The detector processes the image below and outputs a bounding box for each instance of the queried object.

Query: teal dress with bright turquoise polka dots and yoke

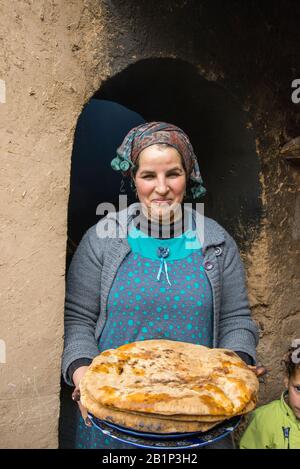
[77,222,213,449]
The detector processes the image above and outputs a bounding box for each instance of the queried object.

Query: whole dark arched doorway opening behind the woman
[60,59,261,448]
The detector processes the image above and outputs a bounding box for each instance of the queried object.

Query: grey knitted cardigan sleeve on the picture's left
[62,226,102,386]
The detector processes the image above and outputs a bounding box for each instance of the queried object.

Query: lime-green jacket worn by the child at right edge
[240,393,300,449]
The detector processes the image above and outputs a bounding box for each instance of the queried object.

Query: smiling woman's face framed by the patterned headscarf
[134,145,186,222]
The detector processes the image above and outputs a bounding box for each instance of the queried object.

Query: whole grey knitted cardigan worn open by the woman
[62,204,258,386]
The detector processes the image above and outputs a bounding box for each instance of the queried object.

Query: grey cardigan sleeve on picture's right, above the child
[218,232,258,363]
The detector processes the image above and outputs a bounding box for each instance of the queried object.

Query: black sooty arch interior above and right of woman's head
[94,58,262,244]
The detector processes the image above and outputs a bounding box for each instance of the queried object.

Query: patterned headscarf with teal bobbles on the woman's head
[111,122,206,199]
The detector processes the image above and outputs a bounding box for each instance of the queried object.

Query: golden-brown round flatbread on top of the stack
[80,339,258,421]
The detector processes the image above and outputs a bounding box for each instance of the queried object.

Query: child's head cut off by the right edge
[284,341,300,420]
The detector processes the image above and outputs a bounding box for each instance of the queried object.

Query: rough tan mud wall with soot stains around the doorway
[0,0,300,448]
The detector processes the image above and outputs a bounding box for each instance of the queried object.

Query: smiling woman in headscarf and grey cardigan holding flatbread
[62,122,258,448]
